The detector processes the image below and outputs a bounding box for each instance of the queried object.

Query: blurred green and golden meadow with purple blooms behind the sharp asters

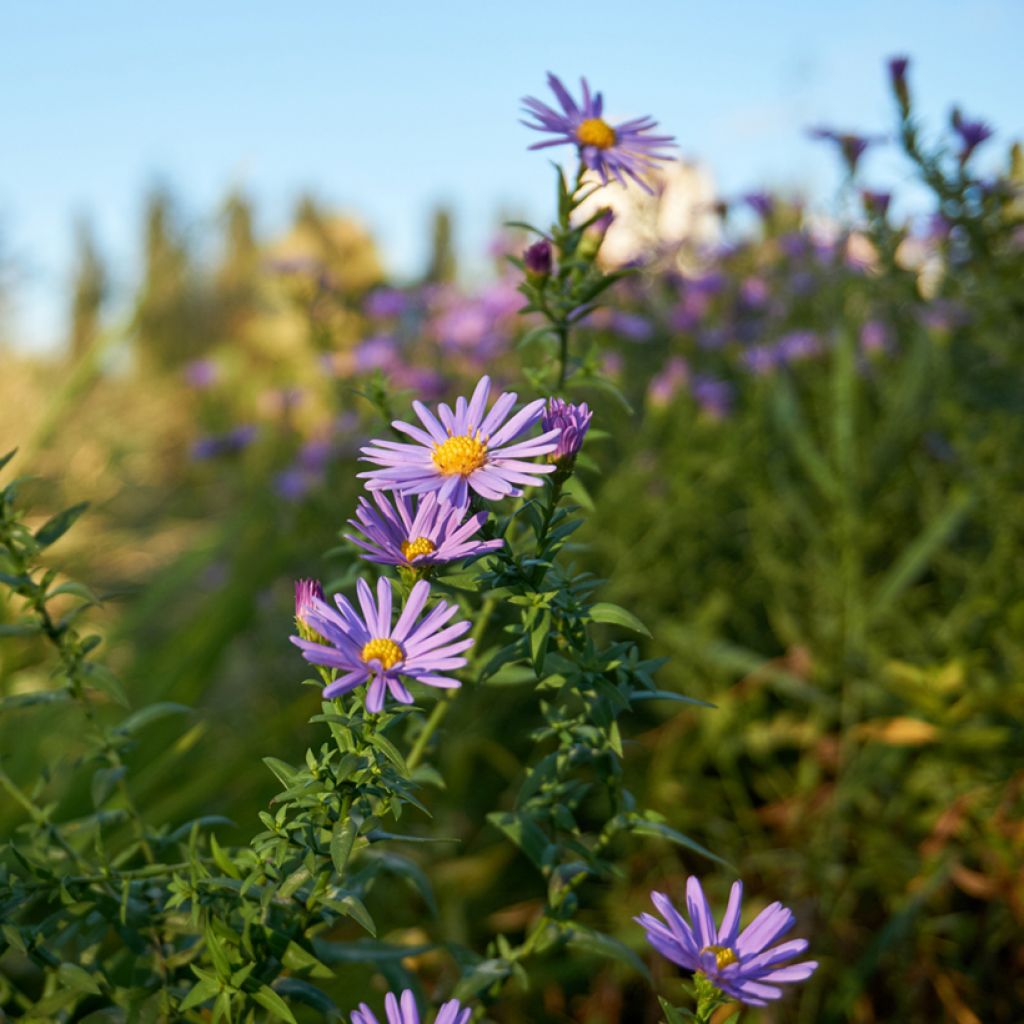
[0,59,1024,1024]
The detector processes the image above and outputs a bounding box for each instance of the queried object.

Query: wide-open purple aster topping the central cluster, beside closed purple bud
[359,377,560,508]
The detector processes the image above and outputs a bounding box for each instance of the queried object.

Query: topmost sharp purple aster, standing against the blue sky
[522,72,675,194]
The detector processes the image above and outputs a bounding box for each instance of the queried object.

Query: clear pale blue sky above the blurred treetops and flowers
[0,0,1024,345]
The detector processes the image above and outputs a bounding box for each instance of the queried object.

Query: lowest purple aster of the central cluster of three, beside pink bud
[291,577,473,712]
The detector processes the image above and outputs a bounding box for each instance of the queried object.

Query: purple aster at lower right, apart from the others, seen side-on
[635,876,818,1007]
